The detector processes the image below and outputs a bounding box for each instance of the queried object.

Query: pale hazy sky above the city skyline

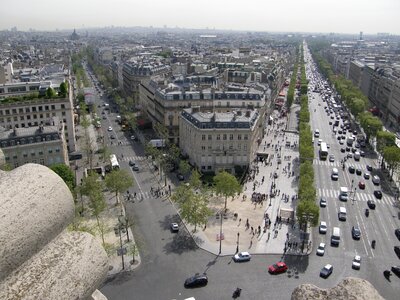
[0,0,400,34]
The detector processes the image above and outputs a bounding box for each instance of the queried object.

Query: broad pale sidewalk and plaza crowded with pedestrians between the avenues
[180,104,312,255]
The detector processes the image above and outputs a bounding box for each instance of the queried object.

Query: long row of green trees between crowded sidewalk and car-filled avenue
[296,48,319,226]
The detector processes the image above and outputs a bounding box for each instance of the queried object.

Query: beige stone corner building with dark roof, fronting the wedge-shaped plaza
[179,106,263,173]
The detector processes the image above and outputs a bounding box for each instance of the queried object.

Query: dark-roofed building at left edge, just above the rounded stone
[0,126,69,168]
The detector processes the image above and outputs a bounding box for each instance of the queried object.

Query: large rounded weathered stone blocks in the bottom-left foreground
[0,164,108,299]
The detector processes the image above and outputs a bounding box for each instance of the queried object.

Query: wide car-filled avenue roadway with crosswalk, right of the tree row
[304,47,400,299]
